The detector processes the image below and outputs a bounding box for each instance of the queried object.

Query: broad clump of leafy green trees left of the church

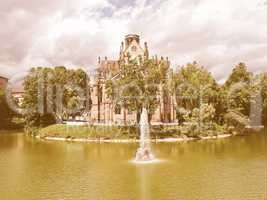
[23,66,90,132]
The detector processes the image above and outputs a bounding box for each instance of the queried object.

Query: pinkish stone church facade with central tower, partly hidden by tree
[90,34,176,124]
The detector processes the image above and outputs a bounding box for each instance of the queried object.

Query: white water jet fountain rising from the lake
[135,108,155,162]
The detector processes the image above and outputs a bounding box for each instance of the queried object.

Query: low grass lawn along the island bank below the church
[37,124,230,139]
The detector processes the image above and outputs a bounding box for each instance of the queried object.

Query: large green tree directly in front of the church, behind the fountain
[106,59,168,122]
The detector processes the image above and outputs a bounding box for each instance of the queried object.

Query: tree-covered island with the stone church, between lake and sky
[1,34,267,142]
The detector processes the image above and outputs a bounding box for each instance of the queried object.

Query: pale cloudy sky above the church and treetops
[0,0,267,82]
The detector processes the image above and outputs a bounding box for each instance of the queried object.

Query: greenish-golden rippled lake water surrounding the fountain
[0,133,267,200]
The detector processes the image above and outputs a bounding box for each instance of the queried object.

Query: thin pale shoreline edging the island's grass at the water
[35,134,235,143]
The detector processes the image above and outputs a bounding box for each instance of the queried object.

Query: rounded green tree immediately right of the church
[171,62,219,122]
